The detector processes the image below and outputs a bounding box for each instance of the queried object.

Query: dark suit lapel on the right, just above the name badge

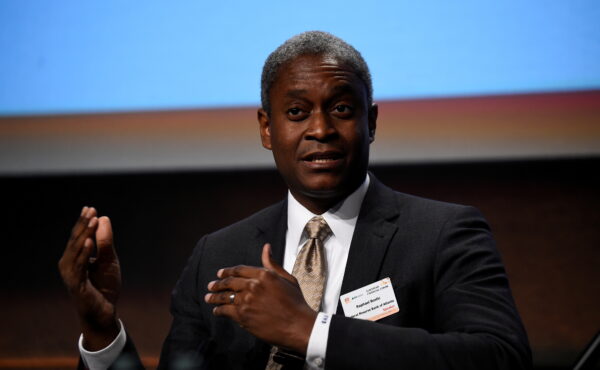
[337,174,398,314]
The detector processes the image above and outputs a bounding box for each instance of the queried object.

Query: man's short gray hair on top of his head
[260,31,373,113]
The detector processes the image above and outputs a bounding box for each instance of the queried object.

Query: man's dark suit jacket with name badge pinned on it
[108,175,531,370]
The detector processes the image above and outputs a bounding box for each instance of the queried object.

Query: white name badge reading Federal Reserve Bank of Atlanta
[340,278,400,321]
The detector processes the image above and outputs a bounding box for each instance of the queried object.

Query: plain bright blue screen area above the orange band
[0,0,600,116]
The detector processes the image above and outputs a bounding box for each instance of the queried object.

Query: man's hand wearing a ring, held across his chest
[205,244,317,354]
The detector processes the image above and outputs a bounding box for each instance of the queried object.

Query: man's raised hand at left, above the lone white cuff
[58,207,121,351]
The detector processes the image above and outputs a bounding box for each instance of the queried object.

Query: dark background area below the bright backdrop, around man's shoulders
[0,158,600,369]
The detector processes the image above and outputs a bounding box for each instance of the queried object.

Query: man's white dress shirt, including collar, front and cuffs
[79,175,370,370]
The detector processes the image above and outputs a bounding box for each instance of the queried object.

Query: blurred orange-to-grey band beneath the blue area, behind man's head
[0,90,600,175]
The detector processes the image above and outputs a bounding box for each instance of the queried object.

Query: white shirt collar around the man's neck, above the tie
[287,174,370,247]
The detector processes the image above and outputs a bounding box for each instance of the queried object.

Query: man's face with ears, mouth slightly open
[258,55,377,212]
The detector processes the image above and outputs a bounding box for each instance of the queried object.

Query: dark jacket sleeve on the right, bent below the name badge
[325,207,531,370]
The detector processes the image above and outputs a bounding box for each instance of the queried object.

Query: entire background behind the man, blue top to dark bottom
[0,0,600,369]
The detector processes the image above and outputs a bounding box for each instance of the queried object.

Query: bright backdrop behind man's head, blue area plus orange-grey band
[0,0,600,175]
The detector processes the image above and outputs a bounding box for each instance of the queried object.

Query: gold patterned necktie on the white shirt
[266,216,331,370]
